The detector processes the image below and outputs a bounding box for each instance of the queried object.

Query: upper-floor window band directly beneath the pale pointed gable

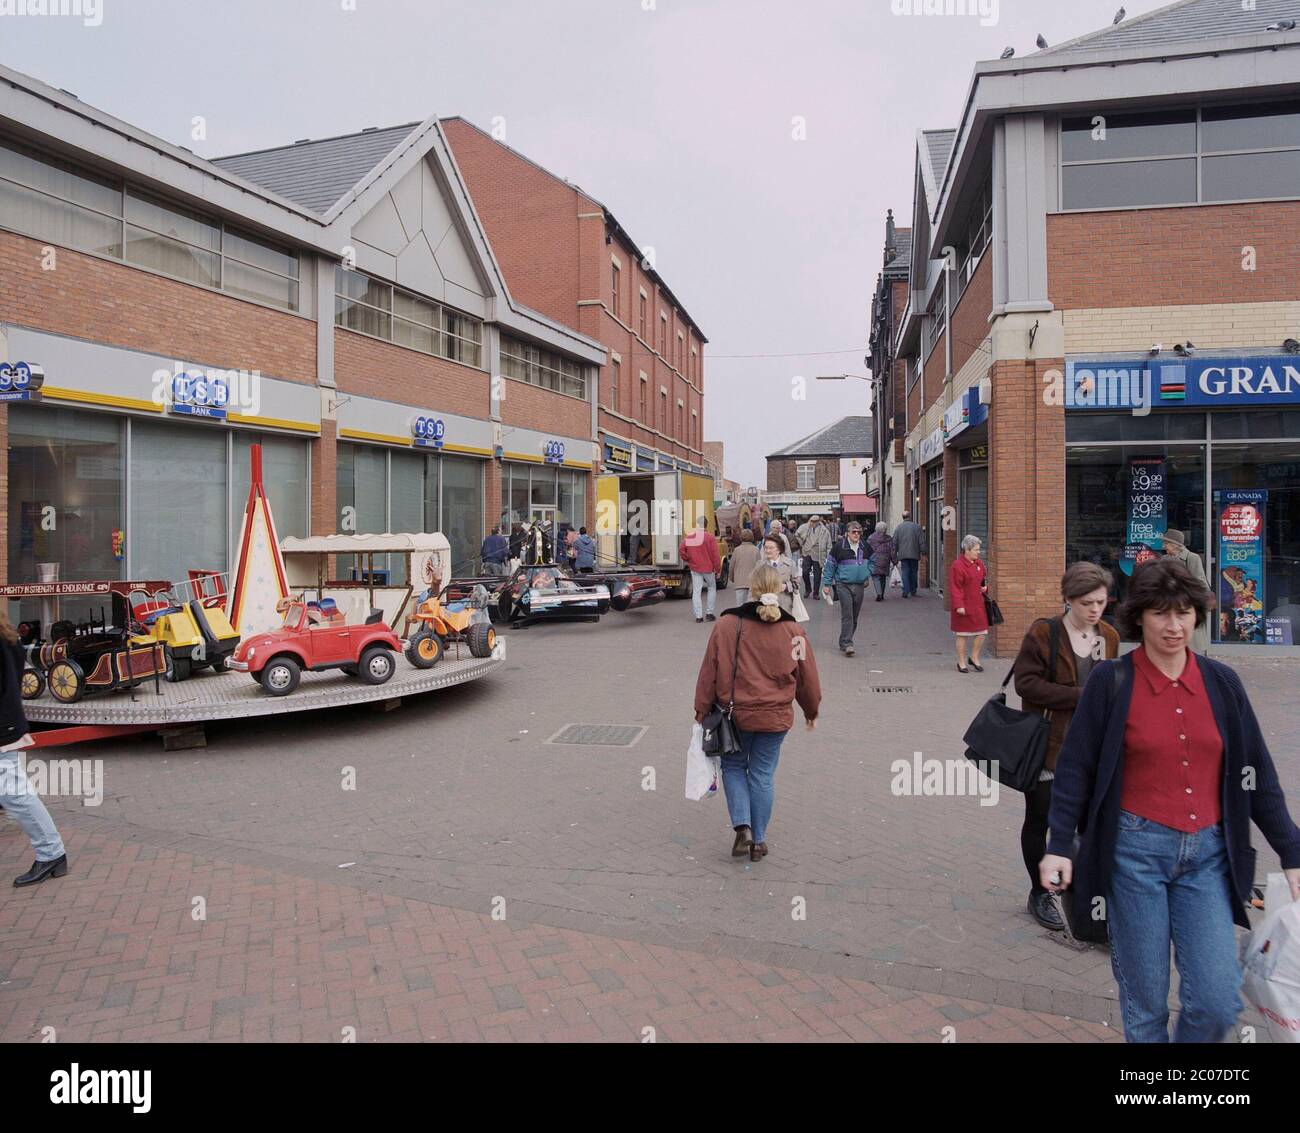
[334,268,484,366]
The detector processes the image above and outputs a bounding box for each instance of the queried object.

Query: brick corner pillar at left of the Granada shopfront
[988,359,1065,656]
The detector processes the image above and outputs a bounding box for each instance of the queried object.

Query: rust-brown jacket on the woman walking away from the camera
[696,602,822,732]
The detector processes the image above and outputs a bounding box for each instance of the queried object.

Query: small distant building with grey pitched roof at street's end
[763,417,876,522]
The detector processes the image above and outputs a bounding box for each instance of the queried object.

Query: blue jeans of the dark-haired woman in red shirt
[1106,811,1242,1042]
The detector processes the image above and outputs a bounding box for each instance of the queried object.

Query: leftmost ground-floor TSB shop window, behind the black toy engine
[8,404,126,621]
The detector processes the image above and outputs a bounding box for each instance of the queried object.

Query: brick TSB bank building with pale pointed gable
[0,69,606,616]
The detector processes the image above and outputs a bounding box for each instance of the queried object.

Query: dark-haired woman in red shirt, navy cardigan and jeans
[1039,559,1300,1042]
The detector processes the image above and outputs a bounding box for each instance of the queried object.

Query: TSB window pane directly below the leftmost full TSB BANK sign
[127,421,230,582]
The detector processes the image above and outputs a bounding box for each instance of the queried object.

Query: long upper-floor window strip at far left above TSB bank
[0,139,298,311]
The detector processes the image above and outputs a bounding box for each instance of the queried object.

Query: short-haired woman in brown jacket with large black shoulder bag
[1011,563,1119,932]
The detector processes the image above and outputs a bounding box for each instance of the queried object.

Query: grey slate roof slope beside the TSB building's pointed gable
[212,122,420,216]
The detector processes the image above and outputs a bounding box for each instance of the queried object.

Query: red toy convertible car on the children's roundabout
[230,596,402,696]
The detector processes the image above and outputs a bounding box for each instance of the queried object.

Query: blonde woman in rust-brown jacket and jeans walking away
[696,565,816,861]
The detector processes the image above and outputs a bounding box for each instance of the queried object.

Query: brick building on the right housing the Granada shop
[881,0,1300,654]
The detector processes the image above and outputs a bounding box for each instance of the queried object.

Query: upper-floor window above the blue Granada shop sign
[1061,103,1300,209]
